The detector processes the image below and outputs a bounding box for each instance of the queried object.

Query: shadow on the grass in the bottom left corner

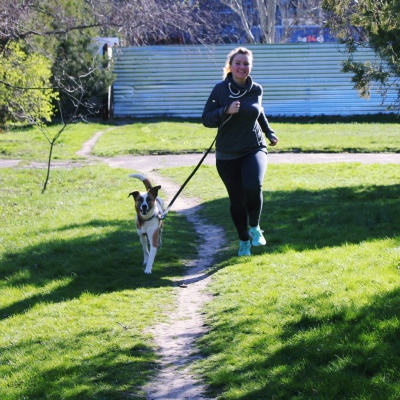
[0,326,157,400]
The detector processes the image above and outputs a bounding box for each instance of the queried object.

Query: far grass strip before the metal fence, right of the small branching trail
[91,119,400,157]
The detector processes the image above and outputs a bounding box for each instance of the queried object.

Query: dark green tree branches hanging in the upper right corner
[323,0,400,112]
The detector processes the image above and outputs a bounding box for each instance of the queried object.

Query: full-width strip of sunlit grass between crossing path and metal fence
[0,116,400,162]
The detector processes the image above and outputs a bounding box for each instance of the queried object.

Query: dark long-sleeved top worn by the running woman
[202,73,274,159]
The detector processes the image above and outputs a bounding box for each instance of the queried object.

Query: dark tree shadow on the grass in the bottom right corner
[203,289,400,400]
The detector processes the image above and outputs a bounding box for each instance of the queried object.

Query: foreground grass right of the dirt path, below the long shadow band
[201,240,400,400]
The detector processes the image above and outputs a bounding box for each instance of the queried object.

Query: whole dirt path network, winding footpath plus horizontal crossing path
[0,132,400,400]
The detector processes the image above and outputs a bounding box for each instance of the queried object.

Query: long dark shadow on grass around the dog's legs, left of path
[0,215,196,318]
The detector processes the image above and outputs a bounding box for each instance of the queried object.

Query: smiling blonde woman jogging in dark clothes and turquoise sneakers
[202,47,278,256]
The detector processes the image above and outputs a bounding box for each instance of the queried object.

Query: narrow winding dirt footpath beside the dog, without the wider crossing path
[79,132,225,400]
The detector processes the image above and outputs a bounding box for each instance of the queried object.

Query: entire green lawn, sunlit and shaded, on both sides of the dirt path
[0,117,400,400]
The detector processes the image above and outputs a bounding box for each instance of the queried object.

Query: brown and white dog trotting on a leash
[128,174,164,274]
